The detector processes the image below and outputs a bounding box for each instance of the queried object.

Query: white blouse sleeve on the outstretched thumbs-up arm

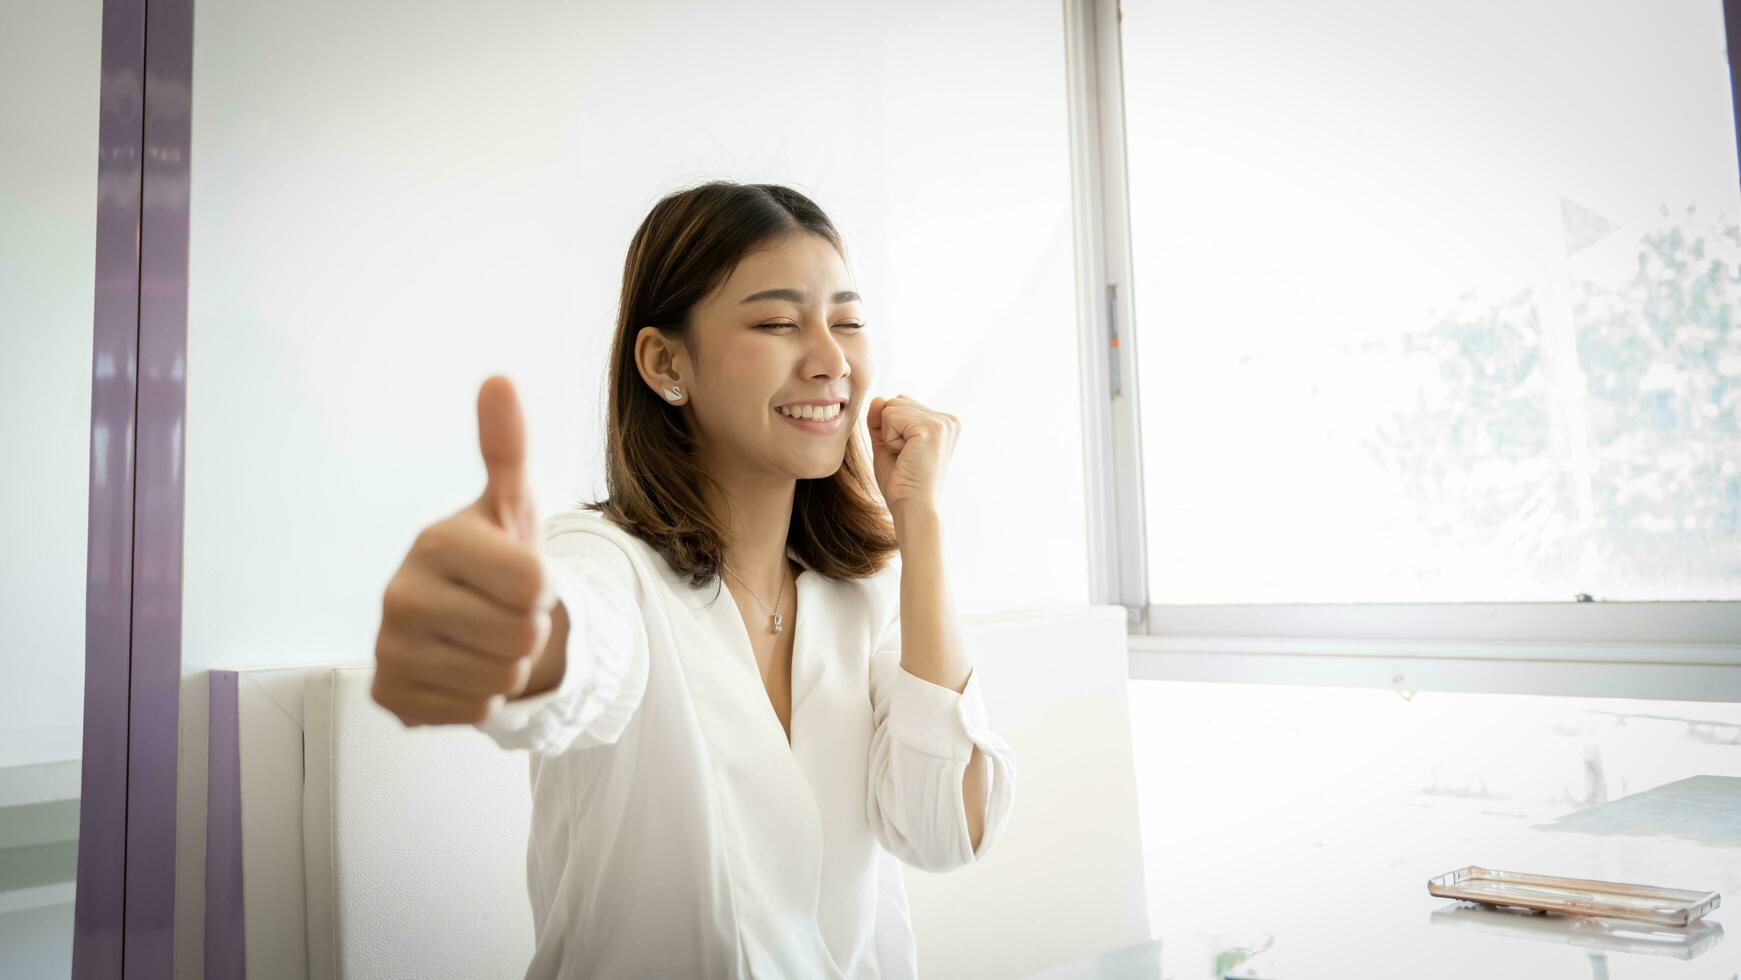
[475,513,651,755]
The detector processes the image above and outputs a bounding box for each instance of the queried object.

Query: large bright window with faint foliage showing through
[1078,0,1741,698]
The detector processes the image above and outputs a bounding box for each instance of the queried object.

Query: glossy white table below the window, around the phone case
[1031,686,1741,980]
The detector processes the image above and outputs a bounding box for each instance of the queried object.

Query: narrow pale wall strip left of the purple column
[0,0,103,769]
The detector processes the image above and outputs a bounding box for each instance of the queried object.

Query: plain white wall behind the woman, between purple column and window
[183,0,1086,672]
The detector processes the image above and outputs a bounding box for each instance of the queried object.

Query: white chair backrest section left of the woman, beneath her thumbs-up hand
[303,665,533,980]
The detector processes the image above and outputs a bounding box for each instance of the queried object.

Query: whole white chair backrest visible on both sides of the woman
[235,607,1149,980]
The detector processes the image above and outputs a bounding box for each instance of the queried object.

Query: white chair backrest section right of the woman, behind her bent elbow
[905,606,1149,980]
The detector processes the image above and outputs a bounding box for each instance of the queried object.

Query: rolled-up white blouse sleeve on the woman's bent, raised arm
[865,614,1015,872]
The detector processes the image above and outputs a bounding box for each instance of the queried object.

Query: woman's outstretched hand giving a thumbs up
[369,376,568,728]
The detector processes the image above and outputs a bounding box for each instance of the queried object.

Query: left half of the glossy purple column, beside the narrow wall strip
[73,0,145,980]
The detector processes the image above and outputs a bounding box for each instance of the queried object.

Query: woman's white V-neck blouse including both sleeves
[477,510,1015,980]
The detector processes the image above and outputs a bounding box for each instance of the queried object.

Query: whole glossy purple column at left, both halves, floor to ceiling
[73,0,193,980]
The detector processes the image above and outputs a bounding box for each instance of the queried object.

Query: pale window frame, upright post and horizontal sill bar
[1064,0,1741,701]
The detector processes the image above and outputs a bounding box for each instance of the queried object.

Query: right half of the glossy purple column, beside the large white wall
[124,0,193,980]
